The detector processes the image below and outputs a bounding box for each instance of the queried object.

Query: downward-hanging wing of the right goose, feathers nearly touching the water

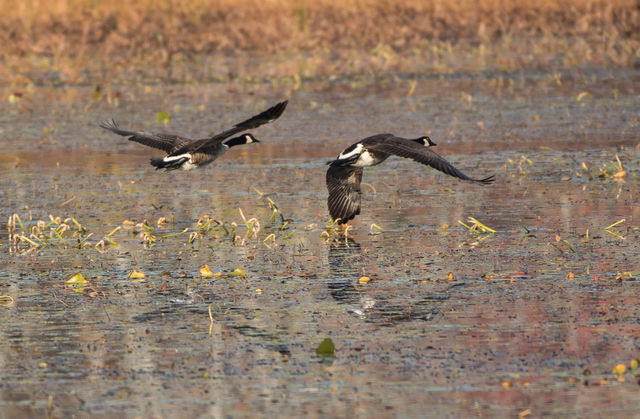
[327,165,362,224]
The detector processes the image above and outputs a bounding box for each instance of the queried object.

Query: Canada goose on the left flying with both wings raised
[100,100,288,170]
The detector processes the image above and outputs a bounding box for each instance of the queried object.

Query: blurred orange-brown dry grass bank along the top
[0,0,640,81]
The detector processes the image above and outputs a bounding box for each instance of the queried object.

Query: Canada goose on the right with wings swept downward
[326,134,494,224]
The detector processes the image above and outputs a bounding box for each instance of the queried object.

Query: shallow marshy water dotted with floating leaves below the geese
[0,71,640,417]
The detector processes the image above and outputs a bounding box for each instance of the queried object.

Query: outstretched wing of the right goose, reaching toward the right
[365,136,495,184]
